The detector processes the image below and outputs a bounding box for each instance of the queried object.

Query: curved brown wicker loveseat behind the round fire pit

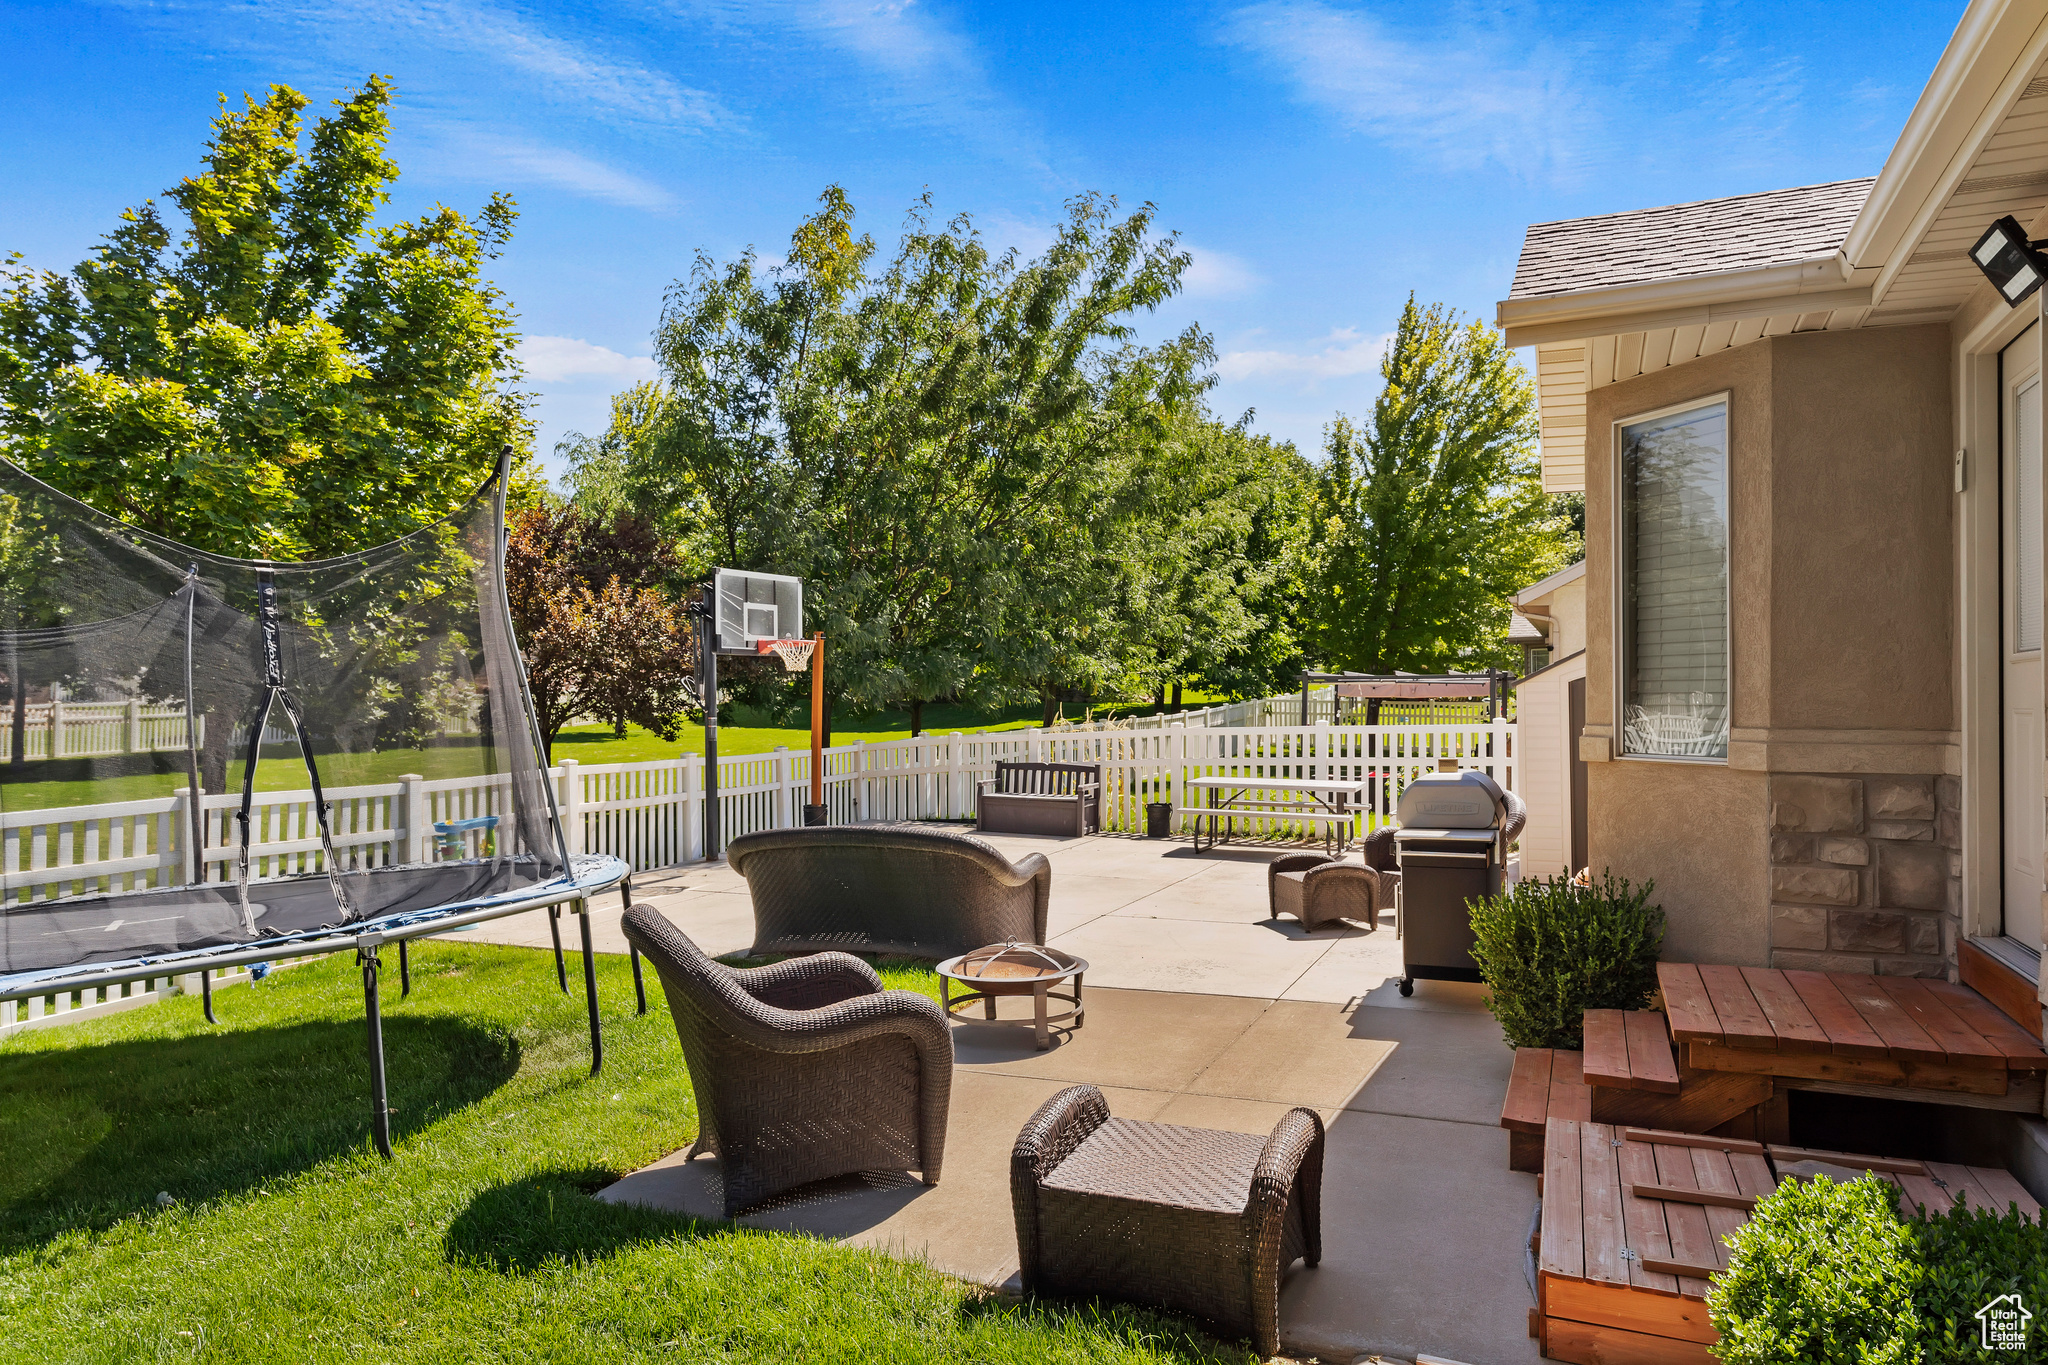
[725,825,1053,958]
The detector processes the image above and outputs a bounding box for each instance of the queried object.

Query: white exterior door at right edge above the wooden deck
[1999,327,2048,954]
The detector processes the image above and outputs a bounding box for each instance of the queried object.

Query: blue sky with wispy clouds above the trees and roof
[0,0,1962,485]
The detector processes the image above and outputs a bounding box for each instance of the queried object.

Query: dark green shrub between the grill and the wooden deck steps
[1470,872,1663,1048]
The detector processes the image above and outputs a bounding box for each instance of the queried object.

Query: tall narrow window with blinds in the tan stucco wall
[1618,399,1729,759]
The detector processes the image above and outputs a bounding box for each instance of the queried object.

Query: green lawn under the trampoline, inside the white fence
[0,941,1249,1365]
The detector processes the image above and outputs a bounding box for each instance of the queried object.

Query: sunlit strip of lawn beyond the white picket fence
[0,696,1208,810]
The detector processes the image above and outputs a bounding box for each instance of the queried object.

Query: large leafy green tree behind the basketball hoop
[569,186,1208,729]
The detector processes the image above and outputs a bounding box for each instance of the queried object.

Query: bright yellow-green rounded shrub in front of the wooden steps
[1706,1175,1916,1365]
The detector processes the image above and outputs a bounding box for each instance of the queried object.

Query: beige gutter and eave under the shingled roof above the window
[1495,255,1867,346]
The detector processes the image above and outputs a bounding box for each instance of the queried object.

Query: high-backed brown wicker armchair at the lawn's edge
[625,905,952,1218]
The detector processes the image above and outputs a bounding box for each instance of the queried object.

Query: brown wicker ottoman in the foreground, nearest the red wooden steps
[1010,1085,1323,1355]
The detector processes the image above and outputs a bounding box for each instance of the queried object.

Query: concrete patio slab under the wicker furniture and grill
[479,835,1540,1365]
